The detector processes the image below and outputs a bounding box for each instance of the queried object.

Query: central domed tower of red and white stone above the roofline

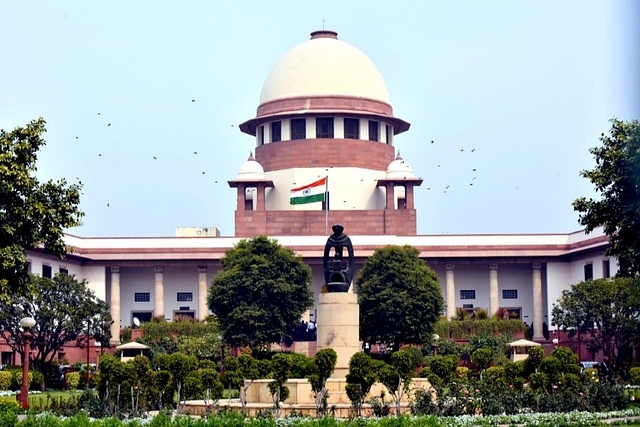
[229,30,422,237]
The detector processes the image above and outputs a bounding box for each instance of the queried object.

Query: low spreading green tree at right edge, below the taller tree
[551,276,640,360]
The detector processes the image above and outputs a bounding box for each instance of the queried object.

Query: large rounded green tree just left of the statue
[208,236,313,348]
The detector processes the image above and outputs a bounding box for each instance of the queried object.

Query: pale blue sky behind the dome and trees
[0,0,640,236]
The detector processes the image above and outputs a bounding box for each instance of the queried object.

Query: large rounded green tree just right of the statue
[356,245,444,348]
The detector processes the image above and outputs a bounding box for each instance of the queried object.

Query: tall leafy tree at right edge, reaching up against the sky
[573,118,640,276]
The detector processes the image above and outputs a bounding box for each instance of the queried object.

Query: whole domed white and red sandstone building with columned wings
[2,30,617,363]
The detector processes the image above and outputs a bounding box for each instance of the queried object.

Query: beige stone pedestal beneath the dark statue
[317,292,361,378]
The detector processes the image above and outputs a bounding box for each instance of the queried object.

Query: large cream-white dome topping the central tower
[260,31,391,105]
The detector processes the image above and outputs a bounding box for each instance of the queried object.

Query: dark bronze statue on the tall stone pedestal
[323,224,353,292]
